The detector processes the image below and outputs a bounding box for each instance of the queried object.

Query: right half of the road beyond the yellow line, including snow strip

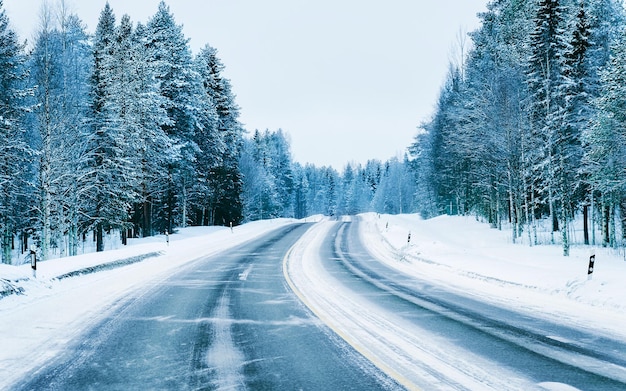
[287,222,626,390]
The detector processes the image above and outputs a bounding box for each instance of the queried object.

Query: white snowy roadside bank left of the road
[0,219,294,389]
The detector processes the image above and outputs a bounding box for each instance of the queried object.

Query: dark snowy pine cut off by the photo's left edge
[0,0,33,264]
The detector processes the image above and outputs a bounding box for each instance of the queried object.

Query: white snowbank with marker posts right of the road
[361,213,626,339]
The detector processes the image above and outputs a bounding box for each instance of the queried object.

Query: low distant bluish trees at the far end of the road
[240,129,416,224]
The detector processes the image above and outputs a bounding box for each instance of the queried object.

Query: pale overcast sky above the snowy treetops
[4,0,487,170]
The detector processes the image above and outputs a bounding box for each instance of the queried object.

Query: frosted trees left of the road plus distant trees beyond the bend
[0,0,414,263]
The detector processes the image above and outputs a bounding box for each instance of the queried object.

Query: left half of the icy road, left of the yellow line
[12,224,397,390]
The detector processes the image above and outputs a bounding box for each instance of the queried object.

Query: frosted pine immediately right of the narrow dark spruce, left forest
[112,15,172,240]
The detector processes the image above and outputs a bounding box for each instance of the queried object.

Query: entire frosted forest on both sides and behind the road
[0,0,626,263]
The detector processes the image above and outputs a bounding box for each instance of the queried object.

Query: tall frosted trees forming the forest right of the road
[411,0,626,255]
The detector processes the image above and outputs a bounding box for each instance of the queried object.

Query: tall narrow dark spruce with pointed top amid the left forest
[87,3,137,251]
